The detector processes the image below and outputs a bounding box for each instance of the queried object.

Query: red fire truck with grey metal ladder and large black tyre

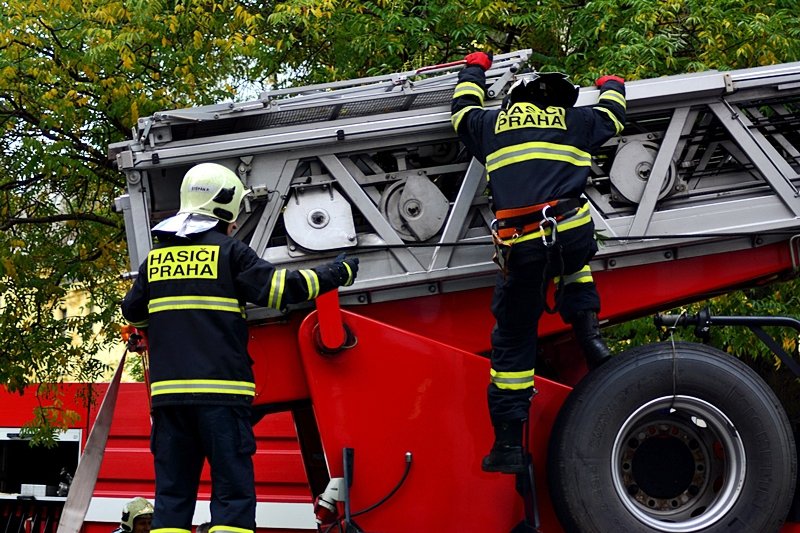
[1,50,800,533]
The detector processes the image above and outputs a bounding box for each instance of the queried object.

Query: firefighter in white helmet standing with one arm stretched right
[122,163,358,533]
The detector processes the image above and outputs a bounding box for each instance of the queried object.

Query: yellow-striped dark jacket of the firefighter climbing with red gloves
[452,66,626,211]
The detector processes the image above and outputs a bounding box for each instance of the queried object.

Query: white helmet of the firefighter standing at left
[178,163,244,222]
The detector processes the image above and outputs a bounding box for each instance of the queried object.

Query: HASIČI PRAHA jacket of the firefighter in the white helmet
[122,230,350,407]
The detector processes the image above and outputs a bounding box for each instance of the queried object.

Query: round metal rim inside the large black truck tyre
[611,395,746,533]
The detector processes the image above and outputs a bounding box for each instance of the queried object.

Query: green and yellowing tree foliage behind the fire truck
[0,0,800,438]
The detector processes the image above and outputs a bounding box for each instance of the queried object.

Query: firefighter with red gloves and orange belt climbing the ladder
[452,52,625,473]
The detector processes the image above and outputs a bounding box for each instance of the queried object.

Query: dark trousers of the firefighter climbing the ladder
[487,223,600,425]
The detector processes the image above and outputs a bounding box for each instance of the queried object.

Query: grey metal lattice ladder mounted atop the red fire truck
[111,51,800,316]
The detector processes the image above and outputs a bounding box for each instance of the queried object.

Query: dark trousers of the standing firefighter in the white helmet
[150,405,256,532]
